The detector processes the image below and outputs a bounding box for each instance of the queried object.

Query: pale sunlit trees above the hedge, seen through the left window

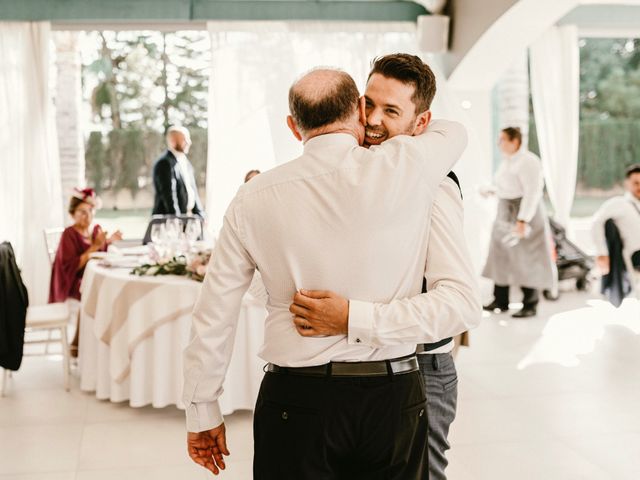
[84,31,209,132]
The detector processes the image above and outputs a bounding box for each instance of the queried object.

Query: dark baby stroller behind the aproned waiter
[543,218,594,300]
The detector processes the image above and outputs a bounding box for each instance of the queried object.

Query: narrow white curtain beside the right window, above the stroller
[530,25,580,227]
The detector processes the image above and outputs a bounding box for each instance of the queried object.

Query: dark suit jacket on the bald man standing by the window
[152,150,204,217]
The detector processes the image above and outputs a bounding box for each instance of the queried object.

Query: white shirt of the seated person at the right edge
[591,192,640,256]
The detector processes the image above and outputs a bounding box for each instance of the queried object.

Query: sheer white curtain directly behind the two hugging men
[206,22,417,229]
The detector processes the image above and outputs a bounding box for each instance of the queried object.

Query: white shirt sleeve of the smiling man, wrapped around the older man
[349,178,482,353]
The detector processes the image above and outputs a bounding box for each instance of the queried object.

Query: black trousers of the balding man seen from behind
[253,371,429,480]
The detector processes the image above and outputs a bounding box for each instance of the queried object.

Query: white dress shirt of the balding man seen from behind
[184,121,466,431]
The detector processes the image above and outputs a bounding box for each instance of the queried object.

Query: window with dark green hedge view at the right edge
[530,38,640,217]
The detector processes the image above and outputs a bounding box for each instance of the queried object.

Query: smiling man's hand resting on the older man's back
[289,290,349,337]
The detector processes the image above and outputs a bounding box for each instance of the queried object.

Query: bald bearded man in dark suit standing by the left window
[152,126,204,217]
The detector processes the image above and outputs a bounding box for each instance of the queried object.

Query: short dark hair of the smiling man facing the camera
[367,53,436,113]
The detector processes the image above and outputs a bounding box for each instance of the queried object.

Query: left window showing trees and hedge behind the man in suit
[81,31,210,236]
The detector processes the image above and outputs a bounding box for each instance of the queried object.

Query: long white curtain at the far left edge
[0,22,63,304]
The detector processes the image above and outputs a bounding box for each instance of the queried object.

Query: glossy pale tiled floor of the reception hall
[0,286,640,480]
